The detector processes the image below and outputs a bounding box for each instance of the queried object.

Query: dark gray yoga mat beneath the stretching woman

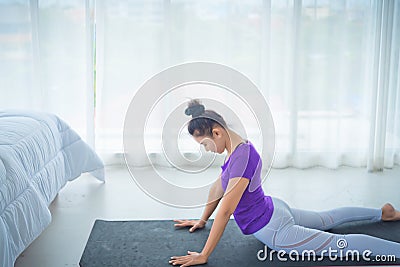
[79,220,400,267]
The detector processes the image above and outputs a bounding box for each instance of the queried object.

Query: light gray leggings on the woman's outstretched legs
[253,198,400,258]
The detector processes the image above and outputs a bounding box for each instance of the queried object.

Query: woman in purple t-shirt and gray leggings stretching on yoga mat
[169,100,400,266]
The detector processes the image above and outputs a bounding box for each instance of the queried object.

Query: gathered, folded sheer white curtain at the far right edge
[367,1,400,171]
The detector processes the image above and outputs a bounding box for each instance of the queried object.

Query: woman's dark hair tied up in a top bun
[185,99,227,136]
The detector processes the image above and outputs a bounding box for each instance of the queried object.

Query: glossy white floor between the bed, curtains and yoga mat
[15,167,400,267]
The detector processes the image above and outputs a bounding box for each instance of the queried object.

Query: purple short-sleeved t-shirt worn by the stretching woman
[221,141,274,235]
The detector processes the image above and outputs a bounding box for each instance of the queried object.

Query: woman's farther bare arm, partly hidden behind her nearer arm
[174,176,224,232]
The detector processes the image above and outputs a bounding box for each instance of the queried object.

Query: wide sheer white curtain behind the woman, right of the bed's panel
[96,0,400,170]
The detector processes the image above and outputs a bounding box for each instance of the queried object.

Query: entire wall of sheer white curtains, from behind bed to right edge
[0,0,400,171]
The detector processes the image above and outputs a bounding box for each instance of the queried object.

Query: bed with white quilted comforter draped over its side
[0,110,104,267]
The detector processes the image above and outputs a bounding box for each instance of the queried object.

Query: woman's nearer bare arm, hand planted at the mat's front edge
[170,177,249,267]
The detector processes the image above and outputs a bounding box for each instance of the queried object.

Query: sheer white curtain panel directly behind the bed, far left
[0,0,94,145]
